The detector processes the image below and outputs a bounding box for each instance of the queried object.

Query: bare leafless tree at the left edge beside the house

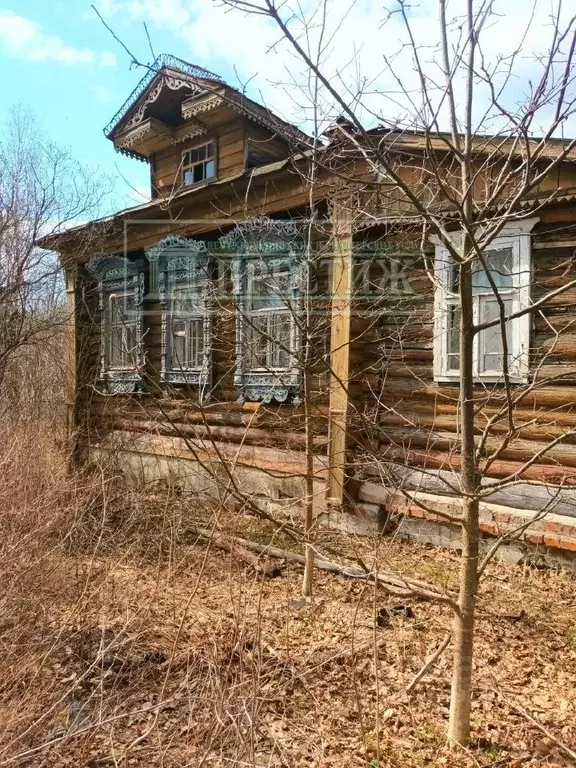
[0,107,107,400]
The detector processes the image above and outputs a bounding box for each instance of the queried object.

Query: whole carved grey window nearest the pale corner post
[227,219,303,405]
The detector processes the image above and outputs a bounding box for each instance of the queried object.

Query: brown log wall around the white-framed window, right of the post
[354,224,576,484]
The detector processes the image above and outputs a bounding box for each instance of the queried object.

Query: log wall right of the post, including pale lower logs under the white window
[350,212,576,528]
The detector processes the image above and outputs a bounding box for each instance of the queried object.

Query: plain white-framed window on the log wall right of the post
[434,219,537,383]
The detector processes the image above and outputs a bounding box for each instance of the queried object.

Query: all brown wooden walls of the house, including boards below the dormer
[51,93,576,552]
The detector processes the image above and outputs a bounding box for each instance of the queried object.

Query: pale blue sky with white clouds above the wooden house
[0,0,573,216]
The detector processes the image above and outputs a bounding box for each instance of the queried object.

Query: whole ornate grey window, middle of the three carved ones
[146,235,212,399]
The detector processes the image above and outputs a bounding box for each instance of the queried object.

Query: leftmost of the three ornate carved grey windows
[90,256,144,394]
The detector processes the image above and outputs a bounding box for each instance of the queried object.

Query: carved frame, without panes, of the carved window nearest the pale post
[226,219,304,405]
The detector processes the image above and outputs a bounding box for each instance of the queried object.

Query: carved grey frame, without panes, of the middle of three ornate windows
[146,235,213,401]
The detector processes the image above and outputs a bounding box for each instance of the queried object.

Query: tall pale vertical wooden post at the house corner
[326,201,352,507]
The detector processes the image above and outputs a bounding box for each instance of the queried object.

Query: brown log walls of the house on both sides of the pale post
[72,195,576,536]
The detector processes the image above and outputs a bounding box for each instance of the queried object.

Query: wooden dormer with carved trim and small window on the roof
[105,55,311,197]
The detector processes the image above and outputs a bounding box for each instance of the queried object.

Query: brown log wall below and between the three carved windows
[78,212,330,503]
